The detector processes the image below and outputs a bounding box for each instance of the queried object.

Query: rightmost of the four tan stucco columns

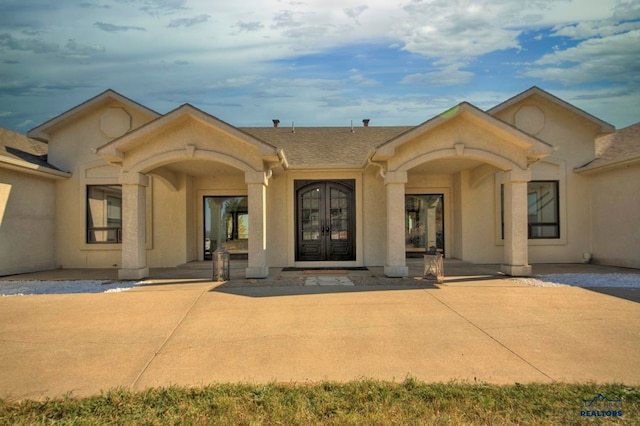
[502,170,531,276]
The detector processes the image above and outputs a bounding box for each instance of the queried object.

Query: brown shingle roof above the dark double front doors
[240,126,413,168]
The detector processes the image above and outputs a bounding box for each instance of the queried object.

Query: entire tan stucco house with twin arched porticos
[0,87,640,279]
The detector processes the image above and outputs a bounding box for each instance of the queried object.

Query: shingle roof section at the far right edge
[579,123,640,171]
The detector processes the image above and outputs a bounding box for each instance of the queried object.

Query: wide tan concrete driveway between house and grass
[0,265,640,400]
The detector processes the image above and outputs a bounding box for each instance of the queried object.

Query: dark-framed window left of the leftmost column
[87,185,122,243]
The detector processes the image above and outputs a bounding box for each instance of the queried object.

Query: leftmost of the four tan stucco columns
[118,172,149,280]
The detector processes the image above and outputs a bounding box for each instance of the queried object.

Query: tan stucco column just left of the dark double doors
[245,172,269,278]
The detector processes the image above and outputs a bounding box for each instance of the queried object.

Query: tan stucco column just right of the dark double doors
[384,172,409,277]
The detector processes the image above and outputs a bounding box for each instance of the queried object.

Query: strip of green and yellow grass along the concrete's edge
[0,378,640,425]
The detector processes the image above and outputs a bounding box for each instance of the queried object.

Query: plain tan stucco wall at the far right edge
[590,165,640,268]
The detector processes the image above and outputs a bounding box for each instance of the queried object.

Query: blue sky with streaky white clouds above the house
[0,0,640,132]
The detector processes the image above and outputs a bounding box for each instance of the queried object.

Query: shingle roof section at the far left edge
[0,127,65,170]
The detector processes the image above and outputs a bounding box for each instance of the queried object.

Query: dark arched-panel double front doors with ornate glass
[295,180,355,261]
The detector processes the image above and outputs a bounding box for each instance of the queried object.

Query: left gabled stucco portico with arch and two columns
[98,105,279,279]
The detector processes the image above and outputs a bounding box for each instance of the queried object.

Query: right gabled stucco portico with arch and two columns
[370,103,553,277]
